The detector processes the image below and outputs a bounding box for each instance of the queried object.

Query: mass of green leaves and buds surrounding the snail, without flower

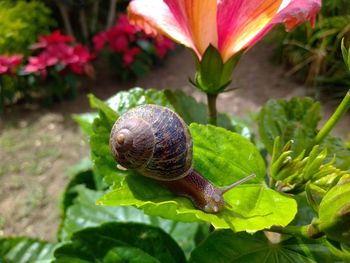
[0,88,350,263]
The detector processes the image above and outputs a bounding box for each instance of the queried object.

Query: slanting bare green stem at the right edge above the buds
[315,90,350,145]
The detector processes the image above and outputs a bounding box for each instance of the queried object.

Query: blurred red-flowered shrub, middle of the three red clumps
[22,31,94,103]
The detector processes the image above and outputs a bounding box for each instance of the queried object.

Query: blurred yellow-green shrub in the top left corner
[0,1,55,54]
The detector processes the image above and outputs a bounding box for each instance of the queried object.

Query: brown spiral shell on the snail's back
[110,105,192,181]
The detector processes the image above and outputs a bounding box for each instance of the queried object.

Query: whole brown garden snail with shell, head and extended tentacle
[110,105,255,213]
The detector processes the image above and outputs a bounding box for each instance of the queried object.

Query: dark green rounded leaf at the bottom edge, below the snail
[53,223,186,263]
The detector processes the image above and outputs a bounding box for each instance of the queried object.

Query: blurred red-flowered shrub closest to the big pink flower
[93,15,175,81]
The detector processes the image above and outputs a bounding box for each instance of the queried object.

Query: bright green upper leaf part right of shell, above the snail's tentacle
[190,123,266,186]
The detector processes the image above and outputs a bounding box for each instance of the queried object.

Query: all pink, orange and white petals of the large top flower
[128,0,321,61]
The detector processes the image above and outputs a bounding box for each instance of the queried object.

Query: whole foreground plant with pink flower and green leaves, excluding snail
[0,0,350,263]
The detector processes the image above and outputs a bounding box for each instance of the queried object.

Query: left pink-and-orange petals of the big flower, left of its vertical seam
[128,0,217,57]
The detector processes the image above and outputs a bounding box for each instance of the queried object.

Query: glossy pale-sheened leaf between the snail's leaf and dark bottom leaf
[59,185,200,255]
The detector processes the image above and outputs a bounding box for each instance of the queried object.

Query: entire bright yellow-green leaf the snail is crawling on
[98,124,296,231]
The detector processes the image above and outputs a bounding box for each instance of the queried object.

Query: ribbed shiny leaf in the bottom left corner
[0,237,56,263]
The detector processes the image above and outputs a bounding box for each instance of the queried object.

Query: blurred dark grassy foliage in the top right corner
[275,0,350,97]
